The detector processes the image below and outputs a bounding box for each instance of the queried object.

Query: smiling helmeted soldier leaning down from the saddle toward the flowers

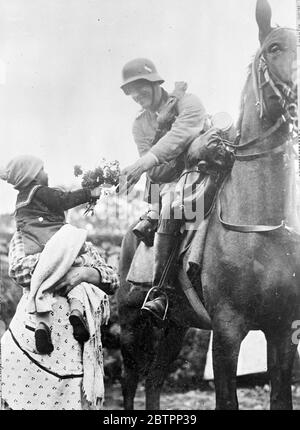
[121,58,207,320]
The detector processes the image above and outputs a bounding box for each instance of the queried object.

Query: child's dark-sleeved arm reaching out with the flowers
[35,186,101,211]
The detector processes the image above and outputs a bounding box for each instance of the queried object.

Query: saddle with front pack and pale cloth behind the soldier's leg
[127,129,234,284]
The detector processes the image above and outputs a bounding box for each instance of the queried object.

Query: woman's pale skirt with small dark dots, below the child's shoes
[1,291,93,410]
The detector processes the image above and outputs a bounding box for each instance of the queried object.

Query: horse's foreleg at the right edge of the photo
[266,330,297,410]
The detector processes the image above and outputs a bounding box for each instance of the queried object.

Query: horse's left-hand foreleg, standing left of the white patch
[213,312,247,410]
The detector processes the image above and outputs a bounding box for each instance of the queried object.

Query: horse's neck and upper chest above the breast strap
[225,91,297,226]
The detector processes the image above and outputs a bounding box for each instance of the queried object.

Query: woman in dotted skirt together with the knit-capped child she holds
[1,156,118,410]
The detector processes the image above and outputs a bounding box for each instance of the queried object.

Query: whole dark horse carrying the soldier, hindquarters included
[118,0,300,409]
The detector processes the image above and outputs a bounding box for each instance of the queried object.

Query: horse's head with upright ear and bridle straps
[255,0,297,121]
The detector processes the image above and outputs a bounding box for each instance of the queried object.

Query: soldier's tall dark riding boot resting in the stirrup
[141,233,178,321]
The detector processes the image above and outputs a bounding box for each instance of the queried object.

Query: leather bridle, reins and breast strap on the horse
[218,28,298,233]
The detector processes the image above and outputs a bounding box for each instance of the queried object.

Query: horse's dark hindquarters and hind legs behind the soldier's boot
[117,223,209,410]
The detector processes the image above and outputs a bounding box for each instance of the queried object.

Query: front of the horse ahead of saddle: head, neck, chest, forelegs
[201,0,300,410]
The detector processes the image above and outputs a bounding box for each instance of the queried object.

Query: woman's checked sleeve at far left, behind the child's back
[8,231,40,288]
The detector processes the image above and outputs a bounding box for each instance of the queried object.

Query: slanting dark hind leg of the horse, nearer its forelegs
[145,324,187,410]
